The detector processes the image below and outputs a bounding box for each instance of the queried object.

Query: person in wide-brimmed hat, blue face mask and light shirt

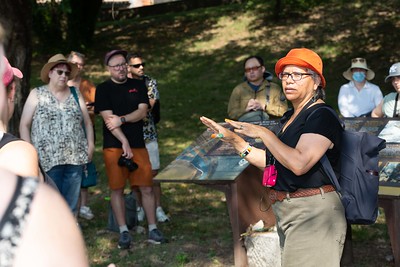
[338,58,383,117]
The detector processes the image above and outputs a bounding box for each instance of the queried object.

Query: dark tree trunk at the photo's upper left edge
[0,0,32,135]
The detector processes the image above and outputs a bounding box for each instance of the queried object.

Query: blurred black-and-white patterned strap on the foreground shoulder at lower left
[0,177,39,267]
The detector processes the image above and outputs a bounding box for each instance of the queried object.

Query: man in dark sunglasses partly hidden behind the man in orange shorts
[126,53,169,222]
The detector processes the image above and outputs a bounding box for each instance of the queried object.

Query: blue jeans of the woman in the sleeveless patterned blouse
[47,164,83,214]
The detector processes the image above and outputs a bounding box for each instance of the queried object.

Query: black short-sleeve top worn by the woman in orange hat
[273,104,343,192]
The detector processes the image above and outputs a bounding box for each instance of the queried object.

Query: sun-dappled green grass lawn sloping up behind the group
[32,0,400,266]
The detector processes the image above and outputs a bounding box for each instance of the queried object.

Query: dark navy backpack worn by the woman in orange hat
[310,106,386,224]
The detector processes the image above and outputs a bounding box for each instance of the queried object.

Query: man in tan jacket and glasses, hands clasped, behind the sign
[228,56,288,122]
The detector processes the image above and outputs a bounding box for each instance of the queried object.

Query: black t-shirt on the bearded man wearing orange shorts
[95,79,150,148]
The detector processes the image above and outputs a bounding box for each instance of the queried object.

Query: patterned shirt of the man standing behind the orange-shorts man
[143,75,160,143]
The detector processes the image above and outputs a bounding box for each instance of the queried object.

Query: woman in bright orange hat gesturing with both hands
[200,48,346,266]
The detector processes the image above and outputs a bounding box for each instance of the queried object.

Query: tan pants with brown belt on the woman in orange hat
[272,192,346,267]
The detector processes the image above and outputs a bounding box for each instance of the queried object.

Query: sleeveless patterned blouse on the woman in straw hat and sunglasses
[31,85,88,172]
